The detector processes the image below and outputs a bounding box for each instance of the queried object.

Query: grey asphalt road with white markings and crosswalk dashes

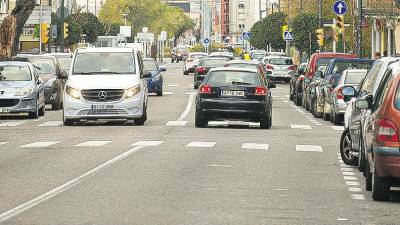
[0,63,400,225]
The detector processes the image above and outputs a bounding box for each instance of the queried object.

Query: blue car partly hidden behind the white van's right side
[143,58,167,96]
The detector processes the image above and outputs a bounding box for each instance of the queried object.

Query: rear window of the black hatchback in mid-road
[207,71,260,85]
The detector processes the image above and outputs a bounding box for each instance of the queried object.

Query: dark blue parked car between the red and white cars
[311,58,374,119]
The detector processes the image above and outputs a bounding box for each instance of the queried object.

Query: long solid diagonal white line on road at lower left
[0,146,143,223]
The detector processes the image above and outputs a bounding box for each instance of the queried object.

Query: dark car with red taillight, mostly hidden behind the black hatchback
[193,57,229,89]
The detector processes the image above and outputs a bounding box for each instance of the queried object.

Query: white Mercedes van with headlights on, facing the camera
[63,48,151,126]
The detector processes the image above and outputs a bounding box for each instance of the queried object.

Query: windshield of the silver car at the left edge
[0,66,32,81]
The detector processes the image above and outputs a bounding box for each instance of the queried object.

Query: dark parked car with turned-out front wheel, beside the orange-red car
[343,57,400,172]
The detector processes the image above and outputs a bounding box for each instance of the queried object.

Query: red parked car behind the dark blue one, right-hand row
[302,53,356,110]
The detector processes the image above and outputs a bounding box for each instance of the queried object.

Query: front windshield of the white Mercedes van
[72,52,135,75]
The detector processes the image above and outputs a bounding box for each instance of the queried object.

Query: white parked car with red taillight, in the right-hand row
[325,69,368,125]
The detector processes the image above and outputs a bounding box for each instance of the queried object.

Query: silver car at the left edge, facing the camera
[0,61,46,119]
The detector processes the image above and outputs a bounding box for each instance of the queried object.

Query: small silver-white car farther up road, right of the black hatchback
[264,56,296,83]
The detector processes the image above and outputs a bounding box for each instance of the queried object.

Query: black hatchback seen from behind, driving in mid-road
[195,68,275,129]
